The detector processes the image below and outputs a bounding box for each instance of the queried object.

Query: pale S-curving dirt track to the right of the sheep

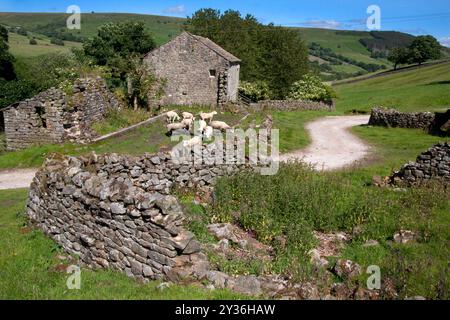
[280,115,369,170]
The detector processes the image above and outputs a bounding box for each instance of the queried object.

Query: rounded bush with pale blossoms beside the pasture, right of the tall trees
[287,74,336,103]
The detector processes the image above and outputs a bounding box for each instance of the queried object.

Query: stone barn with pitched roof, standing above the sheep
[144,32,240,106]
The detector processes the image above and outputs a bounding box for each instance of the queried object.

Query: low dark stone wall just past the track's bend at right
[369,108,434,130]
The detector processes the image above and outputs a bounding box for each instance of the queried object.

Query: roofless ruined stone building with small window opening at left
[3,78,120,150]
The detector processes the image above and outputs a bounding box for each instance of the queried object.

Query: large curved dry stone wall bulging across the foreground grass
[27,147,250,280]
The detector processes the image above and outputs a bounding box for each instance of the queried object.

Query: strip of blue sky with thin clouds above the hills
[0,0,450,46]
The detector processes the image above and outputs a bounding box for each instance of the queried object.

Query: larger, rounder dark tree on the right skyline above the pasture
[409,36,441,65]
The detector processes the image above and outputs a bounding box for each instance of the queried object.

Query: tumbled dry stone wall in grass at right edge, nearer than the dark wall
[389,142,450,185]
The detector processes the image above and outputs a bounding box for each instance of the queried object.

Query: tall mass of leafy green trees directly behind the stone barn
[185,9,308,98]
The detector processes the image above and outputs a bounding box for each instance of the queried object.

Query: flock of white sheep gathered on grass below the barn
[166,111,231,147]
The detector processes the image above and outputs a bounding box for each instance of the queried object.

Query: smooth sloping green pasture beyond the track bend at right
[334,62,450,112]
